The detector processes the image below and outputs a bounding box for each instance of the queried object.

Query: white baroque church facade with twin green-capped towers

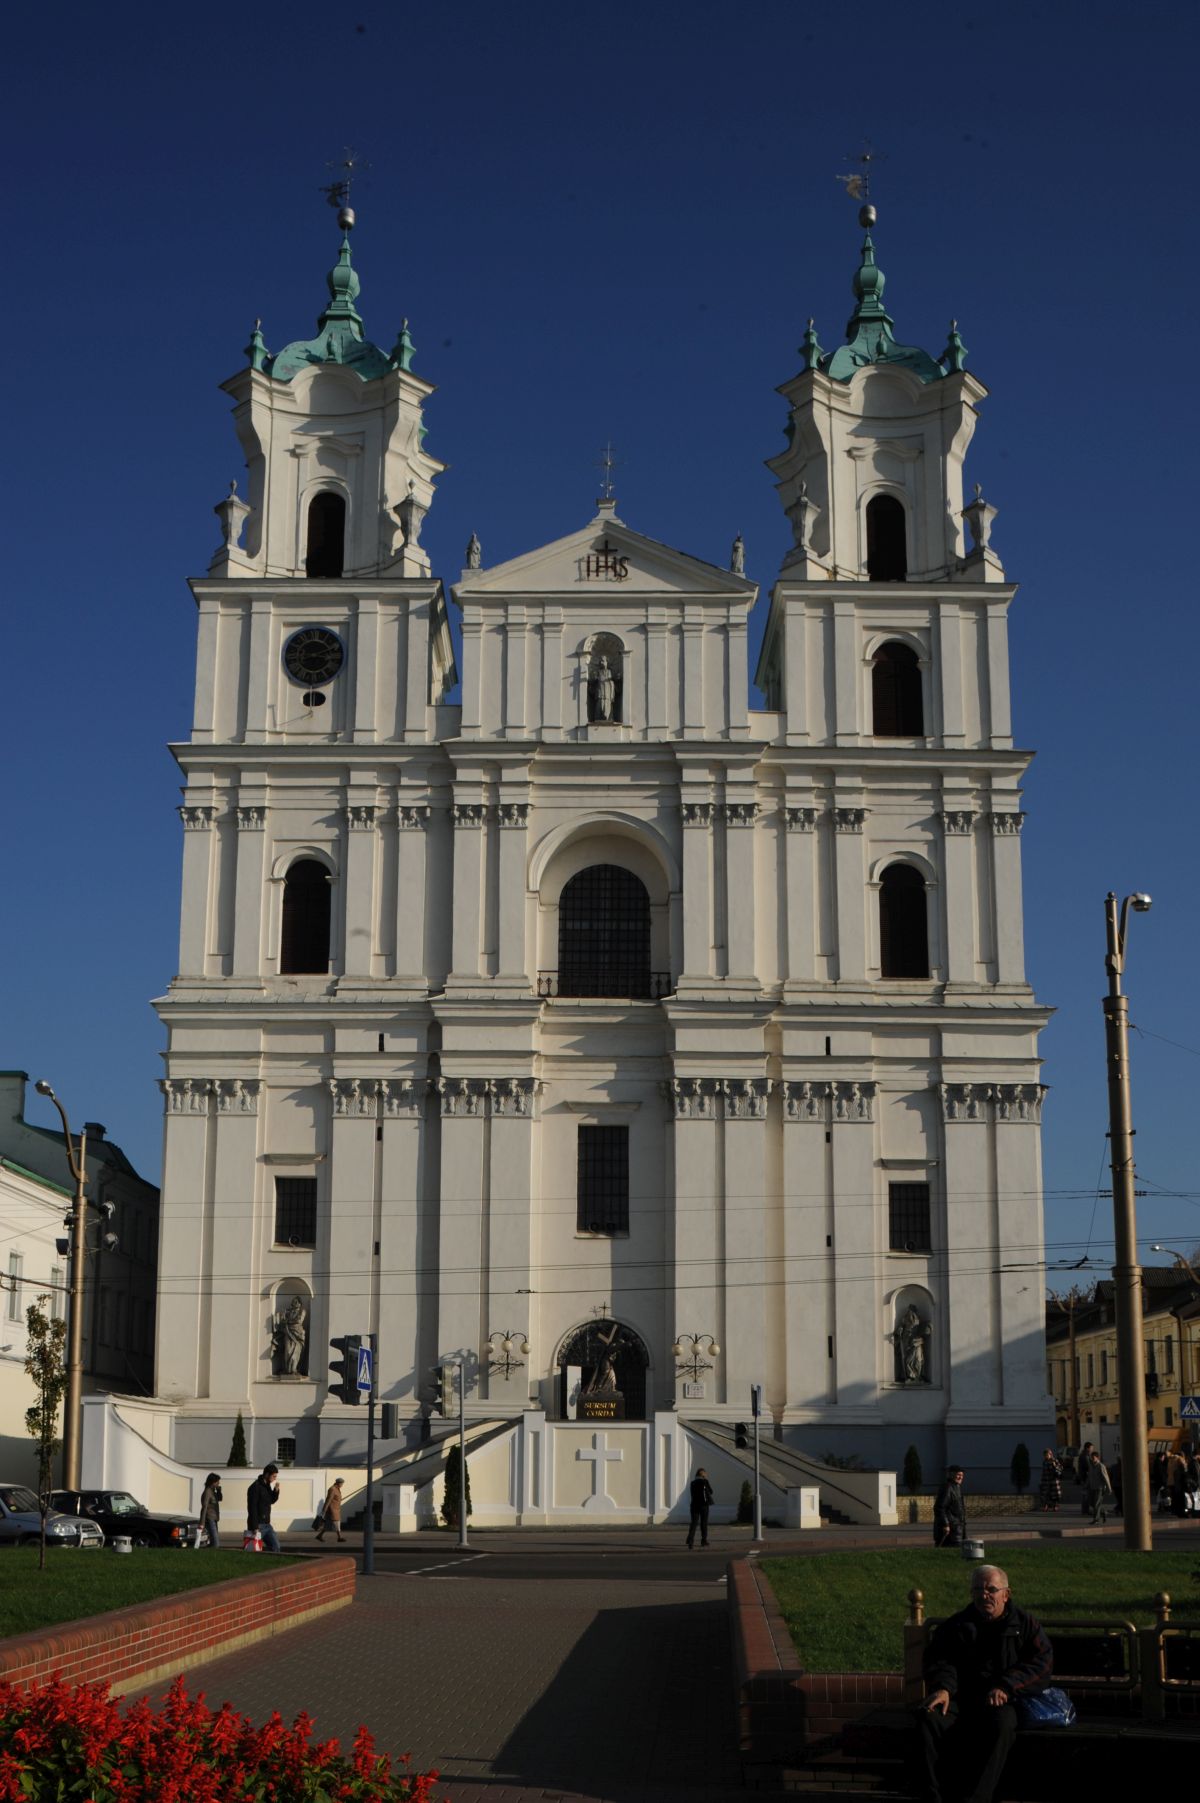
[157,201,1050,1518]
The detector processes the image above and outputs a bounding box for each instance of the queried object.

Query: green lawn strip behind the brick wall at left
[0,1547,300,1637]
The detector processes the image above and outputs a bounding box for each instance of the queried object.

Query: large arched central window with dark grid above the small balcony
[559,864,650,997]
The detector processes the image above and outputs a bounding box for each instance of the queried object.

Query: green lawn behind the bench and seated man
[760,1543,1200,1671]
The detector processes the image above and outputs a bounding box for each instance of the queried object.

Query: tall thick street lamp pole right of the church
[1105,892,1150,1552]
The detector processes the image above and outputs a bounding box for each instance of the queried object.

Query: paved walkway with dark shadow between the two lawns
[152,1543,742,1803]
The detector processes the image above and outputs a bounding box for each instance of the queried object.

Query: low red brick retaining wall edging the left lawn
[0,1554,357,1691]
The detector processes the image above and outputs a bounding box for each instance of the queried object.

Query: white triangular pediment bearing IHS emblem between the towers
[452,512,757,606]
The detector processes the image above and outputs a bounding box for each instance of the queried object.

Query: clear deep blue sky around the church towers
[0,0,1200,1287]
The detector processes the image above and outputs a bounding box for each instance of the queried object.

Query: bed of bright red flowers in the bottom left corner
[0,1679,438,1803]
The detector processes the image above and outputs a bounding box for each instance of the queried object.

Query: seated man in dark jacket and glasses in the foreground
[914,1565,1052,1803]
